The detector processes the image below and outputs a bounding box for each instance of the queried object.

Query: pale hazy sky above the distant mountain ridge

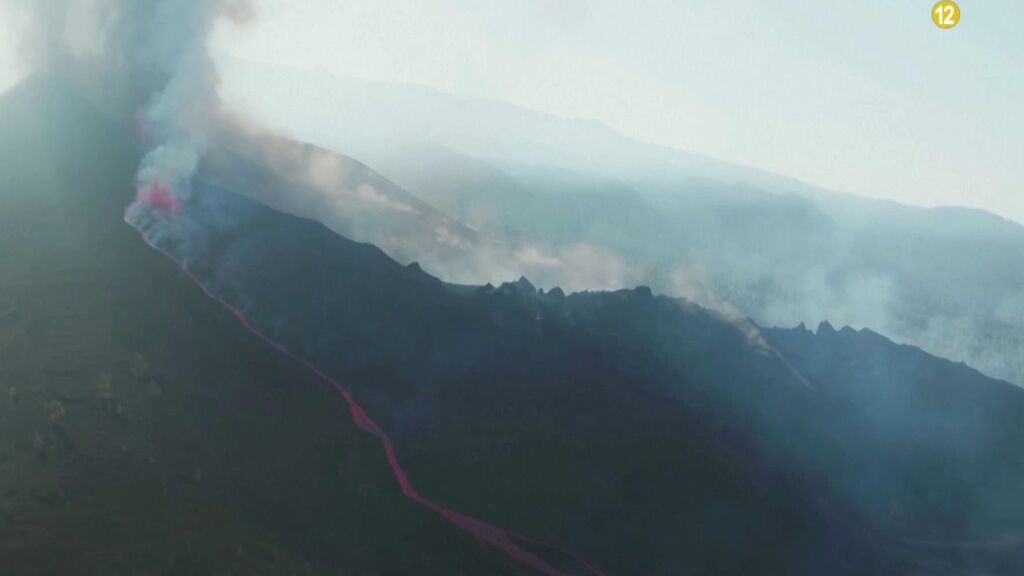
[0,0,1024,222]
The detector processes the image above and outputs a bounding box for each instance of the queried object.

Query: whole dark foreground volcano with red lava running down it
[0,79,1024,576]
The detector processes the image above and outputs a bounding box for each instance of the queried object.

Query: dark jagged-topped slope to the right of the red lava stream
[133,101,1024,575]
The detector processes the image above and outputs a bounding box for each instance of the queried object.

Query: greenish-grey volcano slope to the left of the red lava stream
[0,79,540,575]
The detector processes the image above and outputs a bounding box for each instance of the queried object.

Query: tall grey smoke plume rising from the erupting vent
[0,0,253,219]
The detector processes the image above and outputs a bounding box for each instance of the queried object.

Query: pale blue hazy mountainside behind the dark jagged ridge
[217,54,1024,383]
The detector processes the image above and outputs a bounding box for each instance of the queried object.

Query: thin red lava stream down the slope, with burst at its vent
[125,211,605,576]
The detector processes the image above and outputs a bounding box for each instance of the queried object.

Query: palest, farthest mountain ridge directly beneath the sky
[214,52,1022,233]
